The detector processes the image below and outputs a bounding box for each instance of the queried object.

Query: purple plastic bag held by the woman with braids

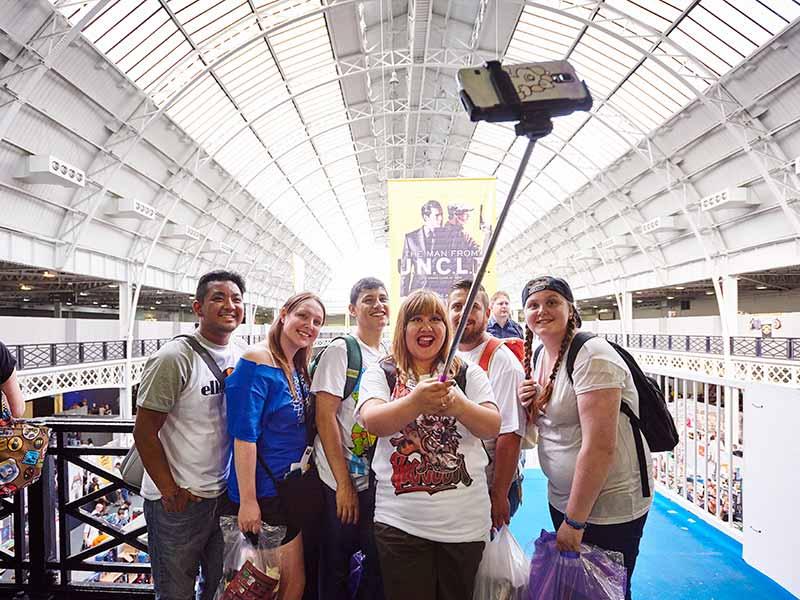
[528,530,627,600]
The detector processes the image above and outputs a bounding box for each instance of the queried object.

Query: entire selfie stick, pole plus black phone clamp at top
[439,61,592,381]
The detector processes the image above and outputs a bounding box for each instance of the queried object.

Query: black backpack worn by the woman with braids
[533,331,678,497]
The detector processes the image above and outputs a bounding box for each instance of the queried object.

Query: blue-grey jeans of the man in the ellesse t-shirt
[144,495,225,600]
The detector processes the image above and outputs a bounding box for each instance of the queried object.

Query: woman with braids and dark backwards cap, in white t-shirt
[519,277,653,599]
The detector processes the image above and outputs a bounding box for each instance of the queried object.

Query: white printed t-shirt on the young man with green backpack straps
[311,336,382,492]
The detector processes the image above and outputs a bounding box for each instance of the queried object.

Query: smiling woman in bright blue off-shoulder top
[225,292,325,599]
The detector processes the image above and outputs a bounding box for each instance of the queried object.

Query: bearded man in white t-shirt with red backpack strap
[447,279,526,528]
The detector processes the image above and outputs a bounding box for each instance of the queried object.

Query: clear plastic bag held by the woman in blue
[214,516,286,600]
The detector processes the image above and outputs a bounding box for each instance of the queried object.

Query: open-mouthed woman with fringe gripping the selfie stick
[356,290,500,600]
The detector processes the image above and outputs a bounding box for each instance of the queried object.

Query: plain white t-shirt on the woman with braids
[534,338,653,525]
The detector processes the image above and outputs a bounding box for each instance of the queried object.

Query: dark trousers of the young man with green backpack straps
[319,485,383,600]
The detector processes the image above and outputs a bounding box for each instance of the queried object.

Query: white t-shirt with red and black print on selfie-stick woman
[356,364,494,543]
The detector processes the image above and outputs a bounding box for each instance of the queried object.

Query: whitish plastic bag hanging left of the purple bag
[472,525,528,600]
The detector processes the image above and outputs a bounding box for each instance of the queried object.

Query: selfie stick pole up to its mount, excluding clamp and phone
[439,113,553,381]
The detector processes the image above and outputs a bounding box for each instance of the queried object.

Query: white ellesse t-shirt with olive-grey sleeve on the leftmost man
[137,330,244,500]
